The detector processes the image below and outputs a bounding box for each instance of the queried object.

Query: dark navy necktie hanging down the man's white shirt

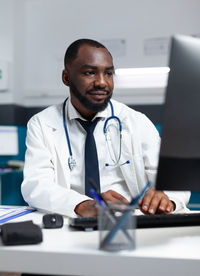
[77,118,100,197]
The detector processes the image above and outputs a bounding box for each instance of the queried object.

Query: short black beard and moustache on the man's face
[70,82,112,113]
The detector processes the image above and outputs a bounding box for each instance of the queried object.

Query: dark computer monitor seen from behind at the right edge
[156,35,200,192]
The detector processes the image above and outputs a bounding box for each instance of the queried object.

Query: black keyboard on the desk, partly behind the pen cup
[69,213,200,230]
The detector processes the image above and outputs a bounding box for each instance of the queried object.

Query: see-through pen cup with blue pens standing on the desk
[98,203,136,252]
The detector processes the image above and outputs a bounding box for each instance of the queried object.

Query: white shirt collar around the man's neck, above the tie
[66,97,111,121]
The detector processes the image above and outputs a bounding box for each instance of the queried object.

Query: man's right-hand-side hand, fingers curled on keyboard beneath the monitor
[138,188,175,215]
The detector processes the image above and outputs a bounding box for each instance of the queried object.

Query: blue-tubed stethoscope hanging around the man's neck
[63,98,130,171]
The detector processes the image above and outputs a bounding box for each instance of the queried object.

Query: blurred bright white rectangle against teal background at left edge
[0,126,19,155]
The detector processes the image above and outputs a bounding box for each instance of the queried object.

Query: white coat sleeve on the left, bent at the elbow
[21,116,90,217]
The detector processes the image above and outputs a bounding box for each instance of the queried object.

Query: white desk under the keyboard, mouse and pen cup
[0,212,200,276]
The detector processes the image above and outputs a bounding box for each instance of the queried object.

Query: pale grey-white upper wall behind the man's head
[0,0,200,105]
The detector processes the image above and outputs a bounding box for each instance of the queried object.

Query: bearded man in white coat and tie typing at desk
[22,39,190,217]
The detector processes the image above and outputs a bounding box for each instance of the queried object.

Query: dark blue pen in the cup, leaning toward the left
[88,179,132,244]
